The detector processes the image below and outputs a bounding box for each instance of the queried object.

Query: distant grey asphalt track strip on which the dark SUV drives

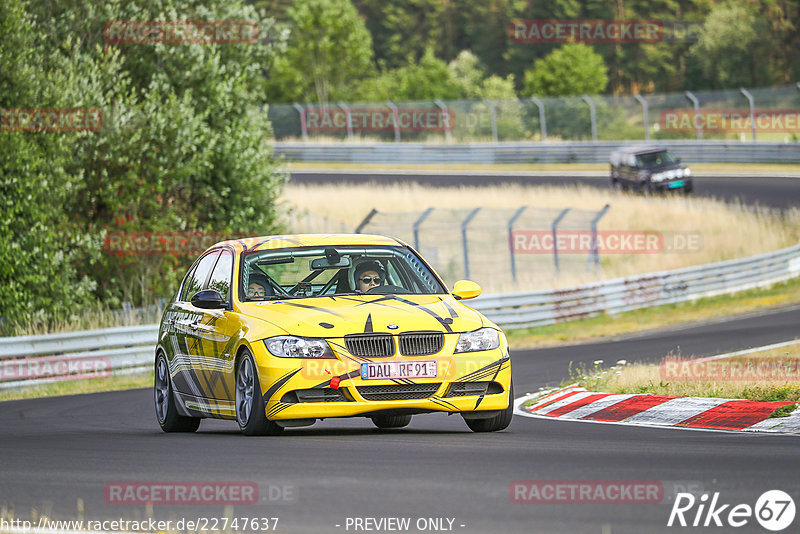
[291,170,800,209]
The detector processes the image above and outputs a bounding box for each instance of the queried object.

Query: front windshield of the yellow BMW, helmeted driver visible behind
[239,245,447,301]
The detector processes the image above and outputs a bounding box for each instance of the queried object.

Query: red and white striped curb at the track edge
[514,386,800,433]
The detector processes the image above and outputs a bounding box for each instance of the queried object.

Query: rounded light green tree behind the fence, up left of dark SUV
[524,43,608,96]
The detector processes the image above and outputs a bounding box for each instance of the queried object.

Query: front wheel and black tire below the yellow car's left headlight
[235,349,283,436]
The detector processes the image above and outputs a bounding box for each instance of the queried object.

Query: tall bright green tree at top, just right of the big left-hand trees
[269,0,374,103]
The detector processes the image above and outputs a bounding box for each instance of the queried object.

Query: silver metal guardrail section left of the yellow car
[0,325,158,388]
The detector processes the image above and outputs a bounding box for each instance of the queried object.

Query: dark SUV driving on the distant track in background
[610,146,693,194]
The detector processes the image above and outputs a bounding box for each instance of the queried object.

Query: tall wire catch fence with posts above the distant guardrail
[267,85,800,143]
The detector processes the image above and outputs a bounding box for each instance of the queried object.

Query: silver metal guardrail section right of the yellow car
[471,245,800,328]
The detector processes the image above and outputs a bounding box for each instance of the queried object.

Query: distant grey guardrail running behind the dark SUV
[274,141,800,164]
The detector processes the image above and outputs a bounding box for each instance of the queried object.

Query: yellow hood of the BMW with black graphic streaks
[241,295,484,338]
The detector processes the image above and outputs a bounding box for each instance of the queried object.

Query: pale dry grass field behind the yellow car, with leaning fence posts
[283,184,800,293]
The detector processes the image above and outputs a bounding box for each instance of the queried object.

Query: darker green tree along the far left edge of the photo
[0,0,97,333]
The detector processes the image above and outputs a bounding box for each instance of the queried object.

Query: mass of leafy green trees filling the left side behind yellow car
[0,0,284,328]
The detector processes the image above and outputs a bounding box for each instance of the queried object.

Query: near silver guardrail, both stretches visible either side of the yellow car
[0,245,800,388]
